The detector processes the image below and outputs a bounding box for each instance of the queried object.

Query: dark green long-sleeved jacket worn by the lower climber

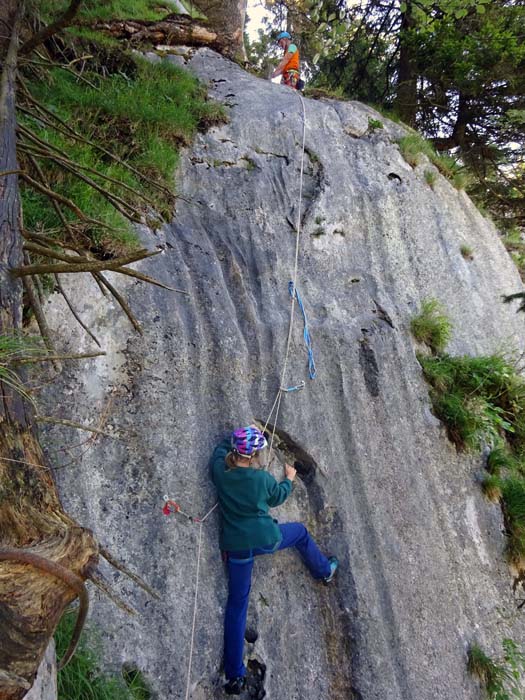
[210,438,292,552]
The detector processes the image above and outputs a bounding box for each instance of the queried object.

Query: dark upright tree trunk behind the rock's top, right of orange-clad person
[394,0,417,126]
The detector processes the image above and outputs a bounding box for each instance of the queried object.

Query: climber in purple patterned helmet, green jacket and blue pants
[210,425,339,695]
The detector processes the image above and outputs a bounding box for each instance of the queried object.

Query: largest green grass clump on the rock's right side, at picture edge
[418,355,525,568]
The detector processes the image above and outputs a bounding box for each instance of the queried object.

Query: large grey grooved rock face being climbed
[42,50,524,700]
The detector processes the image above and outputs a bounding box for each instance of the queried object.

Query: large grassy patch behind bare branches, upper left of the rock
[19,47,224,256]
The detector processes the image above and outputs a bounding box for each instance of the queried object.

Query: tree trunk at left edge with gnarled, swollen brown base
[0,0,98,700]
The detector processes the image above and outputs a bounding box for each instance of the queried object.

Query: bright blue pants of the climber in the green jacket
[224,523,330,680]
